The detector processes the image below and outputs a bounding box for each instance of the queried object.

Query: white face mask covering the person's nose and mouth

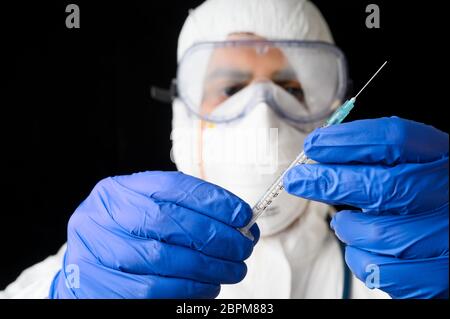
[172,86,307,236]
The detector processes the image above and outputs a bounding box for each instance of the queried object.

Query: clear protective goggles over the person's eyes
[151,40,347,126]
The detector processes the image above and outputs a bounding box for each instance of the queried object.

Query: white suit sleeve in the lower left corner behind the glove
[0,244,66,299]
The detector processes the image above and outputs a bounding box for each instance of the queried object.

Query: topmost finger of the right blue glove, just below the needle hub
[304,117,449,165]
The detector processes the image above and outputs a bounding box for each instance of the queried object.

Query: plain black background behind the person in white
[0,0,448,288]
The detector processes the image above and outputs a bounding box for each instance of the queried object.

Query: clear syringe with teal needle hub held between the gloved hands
[239,61,387,240]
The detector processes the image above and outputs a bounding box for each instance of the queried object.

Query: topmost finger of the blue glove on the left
[112,171,252,228]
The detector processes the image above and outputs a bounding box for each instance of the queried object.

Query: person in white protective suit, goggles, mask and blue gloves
[1,0,448,298]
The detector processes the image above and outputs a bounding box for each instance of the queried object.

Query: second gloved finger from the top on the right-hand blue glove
[283,159,448,214]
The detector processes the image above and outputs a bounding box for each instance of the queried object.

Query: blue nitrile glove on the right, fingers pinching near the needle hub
[284,117,449,298]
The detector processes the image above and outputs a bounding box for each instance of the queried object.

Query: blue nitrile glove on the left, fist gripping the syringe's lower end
[49,172,259,298]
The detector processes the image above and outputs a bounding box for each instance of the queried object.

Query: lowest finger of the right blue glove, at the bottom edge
[345,246,448,299]
